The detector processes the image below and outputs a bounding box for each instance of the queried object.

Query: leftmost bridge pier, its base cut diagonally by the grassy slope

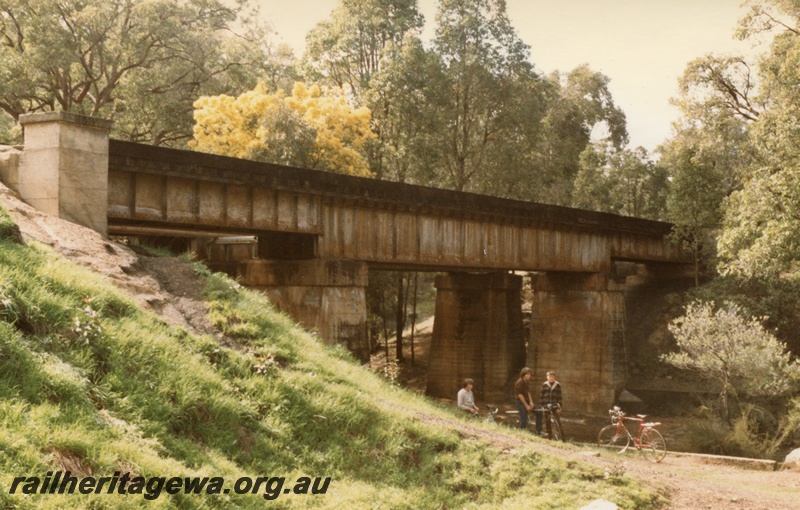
[239,260,369,361]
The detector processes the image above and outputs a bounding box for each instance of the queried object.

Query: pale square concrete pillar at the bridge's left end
[15,112,113,235]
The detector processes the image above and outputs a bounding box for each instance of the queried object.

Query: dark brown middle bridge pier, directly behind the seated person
[426,273,525,403]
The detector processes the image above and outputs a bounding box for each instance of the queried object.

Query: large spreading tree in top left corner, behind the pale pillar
[0,0,269,145]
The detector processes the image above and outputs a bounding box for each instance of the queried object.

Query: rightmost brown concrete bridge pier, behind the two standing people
[527,273,626,413]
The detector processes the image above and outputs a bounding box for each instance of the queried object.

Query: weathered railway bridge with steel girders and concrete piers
[3,112,687,412]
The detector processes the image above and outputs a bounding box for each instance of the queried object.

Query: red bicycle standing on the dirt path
[597,406,667,462]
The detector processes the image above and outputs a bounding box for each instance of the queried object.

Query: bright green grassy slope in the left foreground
[0,205,656,508]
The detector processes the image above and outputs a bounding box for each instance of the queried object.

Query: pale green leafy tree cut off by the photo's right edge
[720,1,800,278]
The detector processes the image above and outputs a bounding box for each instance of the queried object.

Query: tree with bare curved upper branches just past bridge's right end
[658,37,763,287]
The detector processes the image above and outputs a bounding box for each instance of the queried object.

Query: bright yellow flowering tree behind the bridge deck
[189,82,375,177]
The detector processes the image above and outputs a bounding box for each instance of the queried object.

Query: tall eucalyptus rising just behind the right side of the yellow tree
[303,0,425,181]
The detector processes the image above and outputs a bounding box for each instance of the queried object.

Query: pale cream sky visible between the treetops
[258,0,756,153]
